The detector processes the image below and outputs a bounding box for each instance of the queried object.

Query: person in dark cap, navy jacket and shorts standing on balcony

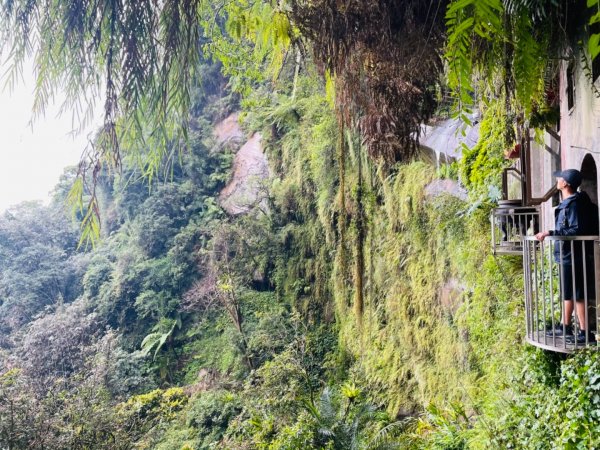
[535,169,598,344]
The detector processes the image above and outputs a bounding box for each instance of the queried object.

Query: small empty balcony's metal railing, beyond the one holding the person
[490,206,540,255]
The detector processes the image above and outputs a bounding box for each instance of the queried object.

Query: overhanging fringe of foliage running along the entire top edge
[0,0,600,238]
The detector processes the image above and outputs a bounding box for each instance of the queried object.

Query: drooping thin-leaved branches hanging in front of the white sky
[0,0,287,241]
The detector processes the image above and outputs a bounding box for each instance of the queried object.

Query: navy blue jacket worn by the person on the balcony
[550,192,598,264]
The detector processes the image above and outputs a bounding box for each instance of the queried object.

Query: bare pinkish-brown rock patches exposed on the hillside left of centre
[215,113,269,215]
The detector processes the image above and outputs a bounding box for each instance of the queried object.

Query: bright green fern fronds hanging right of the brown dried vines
[445,0,572,122]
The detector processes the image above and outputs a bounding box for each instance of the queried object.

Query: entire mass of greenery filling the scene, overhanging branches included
[0,0,600,450]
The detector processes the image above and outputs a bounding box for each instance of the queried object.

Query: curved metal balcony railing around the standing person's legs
[523,236,600,353]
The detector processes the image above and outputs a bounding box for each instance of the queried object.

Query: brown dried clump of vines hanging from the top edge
[288,0,446,162]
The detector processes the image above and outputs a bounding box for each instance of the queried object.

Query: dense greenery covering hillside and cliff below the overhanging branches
[0,58,598,449]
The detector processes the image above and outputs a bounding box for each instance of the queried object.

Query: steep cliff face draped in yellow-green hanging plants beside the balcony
[244,72,523,416]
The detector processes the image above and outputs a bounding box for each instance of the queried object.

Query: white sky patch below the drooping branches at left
[0,68,98,213]
